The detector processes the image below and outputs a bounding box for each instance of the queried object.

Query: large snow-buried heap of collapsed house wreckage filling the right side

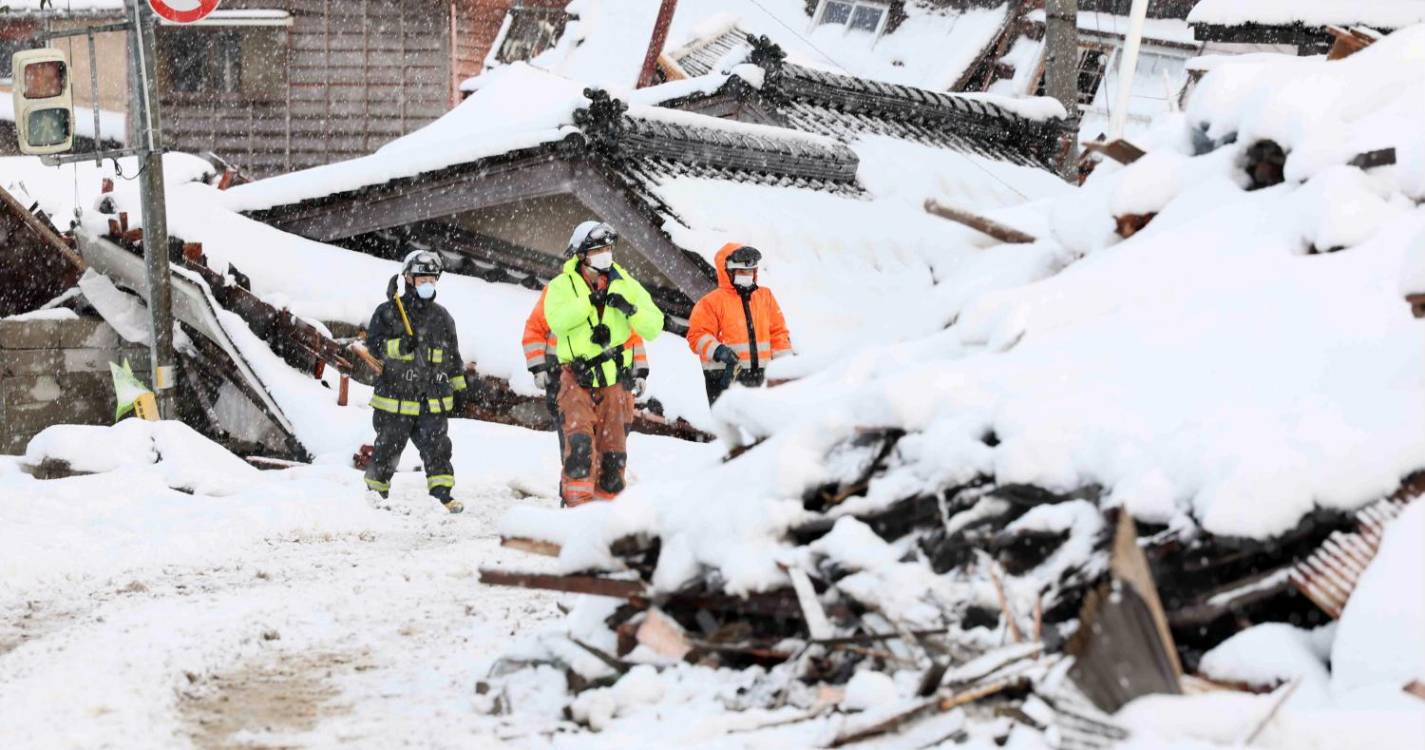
[464,20,1425,747]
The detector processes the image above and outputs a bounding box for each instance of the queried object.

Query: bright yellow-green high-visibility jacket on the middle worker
[544,258,663,388]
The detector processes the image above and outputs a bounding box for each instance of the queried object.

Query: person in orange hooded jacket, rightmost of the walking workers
[688,242,792,404]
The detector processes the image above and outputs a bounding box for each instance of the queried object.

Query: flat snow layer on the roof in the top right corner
[1187,0,1425,29]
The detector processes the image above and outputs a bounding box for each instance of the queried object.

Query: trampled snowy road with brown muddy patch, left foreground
[0,421,713,749]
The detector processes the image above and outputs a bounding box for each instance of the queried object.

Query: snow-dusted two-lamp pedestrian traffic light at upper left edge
[11,48,74,154]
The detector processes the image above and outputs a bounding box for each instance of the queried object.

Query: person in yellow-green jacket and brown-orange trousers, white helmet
[544,221,663,506]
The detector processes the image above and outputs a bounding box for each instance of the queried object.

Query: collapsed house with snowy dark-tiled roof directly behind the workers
[227,43,1063,352]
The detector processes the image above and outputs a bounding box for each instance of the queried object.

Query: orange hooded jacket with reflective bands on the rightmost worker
[688,242,792,369]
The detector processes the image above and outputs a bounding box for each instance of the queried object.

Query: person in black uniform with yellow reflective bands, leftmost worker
[366,251,466,513]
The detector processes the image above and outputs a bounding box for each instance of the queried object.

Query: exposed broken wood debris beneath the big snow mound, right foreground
[480,429,1425,747]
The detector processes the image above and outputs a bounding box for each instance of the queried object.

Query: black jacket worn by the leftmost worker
[366,289,465,399]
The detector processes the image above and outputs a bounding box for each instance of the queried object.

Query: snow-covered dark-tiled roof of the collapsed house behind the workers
[227,58,1066,390]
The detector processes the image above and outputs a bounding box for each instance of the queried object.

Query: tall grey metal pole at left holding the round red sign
[128,0,178,419]
